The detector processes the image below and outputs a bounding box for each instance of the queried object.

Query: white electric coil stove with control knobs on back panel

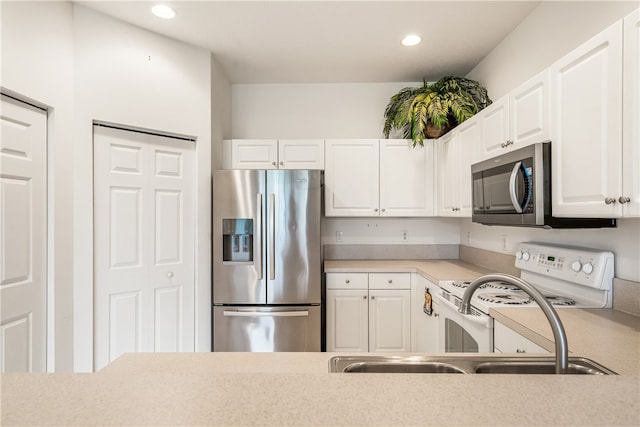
[436,242,614,353]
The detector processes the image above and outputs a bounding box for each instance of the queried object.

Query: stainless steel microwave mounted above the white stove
[471,142,616,228]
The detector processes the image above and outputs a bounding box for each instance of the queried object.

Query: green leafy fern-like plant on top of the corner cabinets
[383,76,492,147]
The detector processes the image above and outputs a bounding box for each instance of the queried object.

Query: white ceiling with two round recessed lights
[75,0,540,83]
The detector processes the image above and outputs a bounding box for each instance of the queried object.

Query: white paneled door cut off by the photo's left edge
[0,95,47,372]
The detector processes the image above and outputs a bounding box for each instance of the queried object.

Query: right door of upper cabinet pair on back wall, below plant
[380,139,434,217]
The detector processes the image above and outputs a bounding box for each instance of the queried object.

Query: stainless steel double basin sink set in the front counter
[329,355,616,375]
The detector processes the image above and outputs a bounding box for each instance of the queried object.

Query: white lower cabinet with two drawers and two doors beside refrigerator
[326,273,411,352]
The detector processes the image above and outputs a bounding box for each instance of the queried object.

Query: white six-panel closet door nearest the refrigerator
[94,126,195,370]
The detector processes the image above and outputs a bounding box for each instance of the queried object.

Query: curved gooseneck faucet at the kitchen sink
[458,274,569,374]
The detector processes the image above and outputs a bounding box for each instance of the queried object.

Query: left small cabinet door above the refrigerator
[231,139,278,169]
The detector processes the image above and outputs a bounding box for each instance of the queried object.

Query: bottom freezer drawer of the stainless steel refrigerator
[213,305,321,352]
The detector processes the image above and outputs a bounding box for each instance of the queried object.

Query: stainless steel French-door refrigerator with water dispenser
[213,170,321,351]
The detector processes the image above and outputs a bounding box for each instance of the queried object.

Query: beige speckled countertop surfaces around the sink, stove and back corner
[0,260,640,426]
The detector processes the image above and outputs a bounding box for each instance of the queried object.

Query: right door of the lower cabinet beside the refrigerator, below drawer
[369,289,411,352]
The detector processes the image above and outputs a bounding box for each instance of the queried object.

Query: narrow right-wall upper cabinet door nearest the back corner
[438,130,460,216]
